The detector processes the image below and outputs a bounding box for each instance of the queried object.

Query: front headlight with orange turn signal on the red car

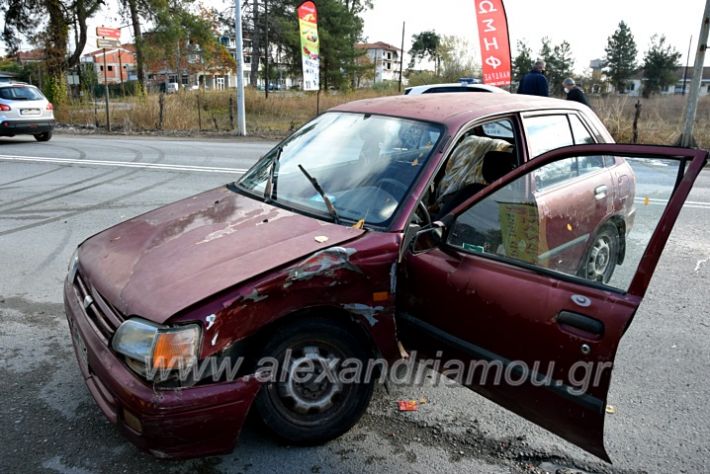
[111,318,200,378]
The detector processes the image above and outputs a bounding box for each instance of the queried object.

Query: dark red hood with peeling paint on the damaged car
[79,187,364,323]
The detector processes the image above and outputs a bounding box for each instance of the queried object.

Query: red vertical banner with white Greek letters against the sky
[473,0,511,86]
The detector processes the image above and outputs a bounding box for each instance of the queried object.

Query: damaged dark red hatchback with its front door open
[64,94,708,460]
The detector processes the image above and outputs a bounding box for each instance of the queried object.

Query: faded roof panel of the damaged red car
[330,92,590,129]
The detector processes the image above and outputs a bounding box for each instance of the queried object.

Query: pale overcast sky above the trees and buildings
[0,0,710,74]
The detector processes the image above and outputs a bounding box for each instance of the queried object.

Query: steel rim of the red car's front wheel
[278,346,343,414]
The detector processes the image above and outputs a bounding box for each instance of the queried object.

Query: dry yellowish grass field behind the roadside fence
[56,89,710,148]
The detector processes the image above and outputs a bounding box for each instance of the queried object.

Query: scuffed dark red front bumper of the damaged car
[64,280,260,457]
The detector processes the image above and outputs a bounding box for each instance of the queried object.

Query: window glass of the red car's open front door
[447,156,680,291]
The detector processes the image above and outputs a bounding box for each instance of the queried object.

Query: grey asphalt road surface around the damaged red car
[0,135,710,474]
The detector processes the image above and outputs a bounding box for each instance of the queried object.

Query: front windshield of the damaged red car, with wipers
[237,112,442,227]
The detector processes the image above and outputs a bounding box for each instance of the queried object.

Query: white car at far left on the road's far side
[0,82,55,142]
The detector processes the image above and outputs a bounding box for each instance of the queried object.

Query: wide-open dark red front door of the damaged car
[397,144,708,461]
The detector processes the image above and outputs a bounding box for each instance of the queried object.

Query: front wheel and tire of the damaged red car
[254,318,373,445]
